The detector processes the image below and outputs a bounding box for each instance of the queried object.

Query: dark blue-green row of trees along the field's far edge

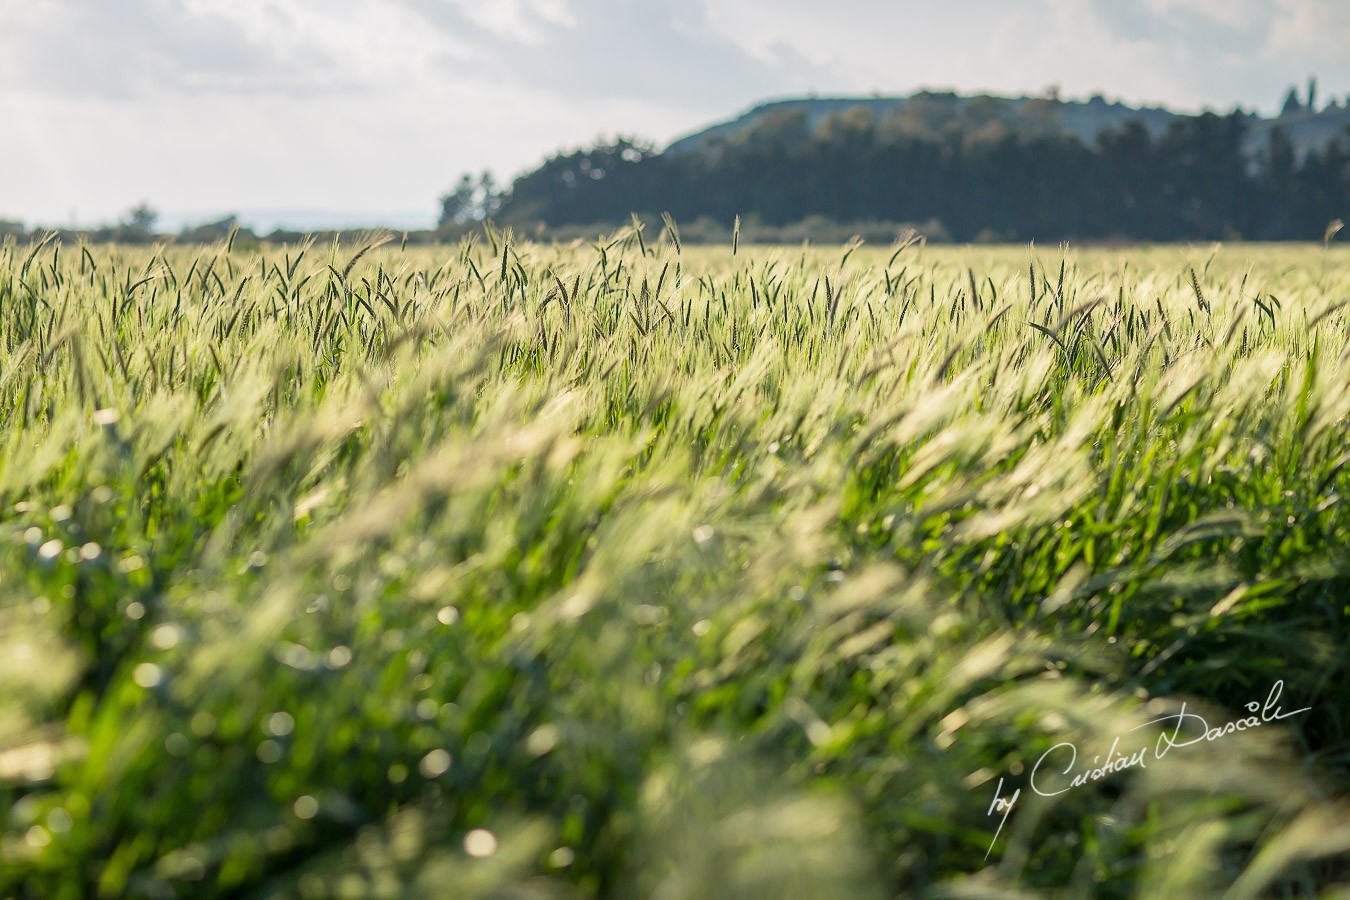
[453,101,1350,242]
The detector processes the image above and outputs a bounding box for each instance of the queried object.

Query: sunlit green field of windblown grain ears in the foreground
[0,231,1350,900]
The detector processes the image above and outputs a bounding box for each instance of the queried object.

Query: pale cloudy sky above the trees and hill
[0,0,1350,228]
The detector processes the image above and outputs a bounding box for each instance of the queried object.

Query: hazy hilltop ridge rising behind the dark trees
[666,90,1350,157]
